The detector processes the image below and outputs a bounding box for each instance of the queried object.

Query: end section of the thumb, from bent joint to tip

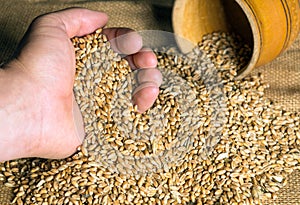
[41,8,108,38]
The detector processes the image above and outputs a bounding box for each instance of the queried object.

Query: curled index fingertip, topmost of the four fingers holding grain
[103,28,143,55]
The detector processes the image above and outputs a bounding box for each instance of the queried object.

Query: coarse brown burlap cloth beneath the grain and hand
[0,0,300,205]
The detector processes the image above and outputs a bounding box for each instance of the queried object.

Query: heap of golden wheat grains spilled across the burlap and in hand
[0,30,300,205]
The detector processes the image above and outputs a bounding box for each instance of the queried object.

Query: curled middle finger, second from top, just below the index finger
[126,48,157,70]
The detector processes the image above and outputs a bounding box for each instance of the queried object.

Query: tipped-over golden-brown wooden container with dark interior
[172,0,300,78]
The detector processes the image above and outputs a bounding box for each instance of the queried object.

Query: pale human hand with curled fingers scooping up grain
[0,8,161,161]
